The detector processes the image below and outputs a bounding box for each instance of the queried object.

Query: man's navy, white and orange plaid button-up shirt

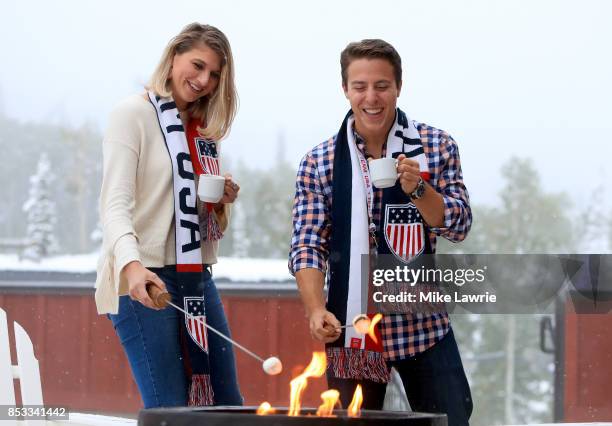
[289,123,472,361]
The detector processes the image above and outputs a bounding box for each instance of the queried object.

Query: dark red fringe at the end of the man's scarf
[326,347,391,383]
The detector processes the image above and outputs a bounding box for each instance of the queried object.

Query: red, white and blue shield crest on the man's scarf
[384,203,425,263]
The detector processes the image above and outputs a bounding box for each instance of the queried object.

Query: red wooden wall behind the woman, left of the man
[0,289,326,413]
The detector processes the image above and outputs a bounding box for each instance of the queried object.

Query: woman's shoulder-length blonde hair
[146,22,238,141]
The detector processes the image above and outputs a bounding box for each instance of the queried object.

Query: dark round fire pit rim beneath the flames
[138,406,447,426]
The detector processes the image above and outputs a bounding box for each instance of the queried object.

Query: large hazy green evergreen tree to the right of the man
[439,158,581,426]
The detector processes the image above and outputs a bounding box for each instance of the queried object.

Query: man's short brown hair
[340,38,402,87]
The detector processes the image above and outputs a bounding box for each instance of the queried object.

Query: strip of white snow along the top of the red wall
[0,253,293,282]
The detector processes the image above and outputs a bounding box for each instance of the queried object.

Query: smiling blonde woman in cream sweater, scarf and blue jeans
[96,23,242,408]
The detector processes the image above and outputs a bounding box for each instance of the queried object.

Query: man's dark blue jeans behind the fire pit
[327,328,472,426]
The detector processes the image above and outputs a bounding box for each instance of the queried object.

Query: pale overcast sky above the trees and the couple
[0,0,612,204]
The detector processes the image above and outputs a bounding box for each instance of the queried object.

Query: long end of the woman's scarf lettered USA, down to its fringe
[148,92,216,405]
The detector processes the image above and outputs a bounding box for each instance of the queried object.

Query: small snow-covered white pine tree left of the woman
[23,153,59,261]
